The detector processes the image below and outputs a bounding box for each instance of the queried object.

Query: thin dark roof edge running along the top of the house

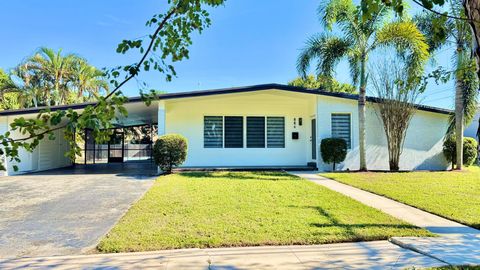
[0,83,453,116]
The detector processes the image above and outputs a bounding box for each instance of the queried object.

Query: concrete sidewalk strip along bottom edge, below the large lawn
[0,241,445,270]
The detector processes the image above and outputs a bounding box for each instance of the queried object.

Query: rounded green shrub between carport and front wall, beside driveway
[153,134,187,173]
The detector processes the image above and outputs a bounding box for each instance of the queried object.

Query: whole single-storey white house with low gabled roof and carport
[0,84,451,174]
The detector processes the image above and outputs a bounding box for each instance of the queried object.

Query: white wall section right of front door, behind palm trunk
[318,96,449,170]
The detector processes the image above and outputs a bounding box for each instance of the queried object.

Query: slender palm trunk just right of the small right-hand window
[358,55,367,171]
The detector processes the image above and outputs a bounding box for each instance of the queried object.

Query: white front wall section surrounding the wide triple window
[166,91,315,167]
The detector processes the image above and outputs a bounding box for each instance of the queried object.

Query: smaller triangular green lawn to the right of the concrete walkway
[322,167,480,229]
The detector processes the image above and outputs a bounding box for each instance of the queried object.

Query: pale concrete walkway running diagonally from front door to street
[290,172,480,265]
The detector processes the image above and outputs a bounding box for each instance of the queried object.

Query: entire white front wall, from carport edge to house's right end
[165,91,448,170]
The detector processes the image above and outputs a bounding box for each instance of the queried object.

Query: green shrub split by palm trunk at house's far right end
[443,135,478,167]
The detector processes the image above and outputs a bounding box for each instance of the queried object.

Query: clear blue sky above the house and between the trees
[0,0,453,108]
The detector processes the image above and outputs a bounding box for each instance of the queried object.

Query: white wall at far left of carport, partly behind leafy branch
[0,116,71,175]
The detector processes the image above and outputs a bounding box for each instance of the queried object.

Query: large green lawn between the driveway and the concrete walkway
[98,172,430,252]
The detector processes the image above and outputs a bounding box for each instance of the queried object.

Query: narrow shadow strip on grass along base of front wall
[178,171,301,181]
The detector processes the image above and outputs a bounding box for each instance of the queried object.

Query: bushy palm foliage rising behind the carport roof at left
[4,48,108,107]
